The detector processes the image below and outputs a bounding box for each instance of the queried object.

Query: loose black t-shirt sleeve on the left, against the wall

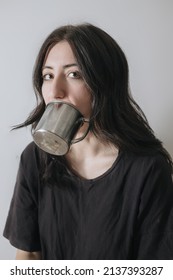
[3,145,40,252]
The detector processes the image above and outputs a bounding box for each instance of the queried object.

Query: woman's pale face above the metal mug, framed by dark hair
[42,41,92,118]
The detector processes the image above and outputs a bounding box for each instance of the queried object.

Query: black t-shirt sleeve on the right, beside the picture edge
[134,154,173,260]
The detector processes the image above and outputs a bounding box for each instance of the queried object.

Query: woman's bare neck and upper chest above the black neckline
[65,132,118,179]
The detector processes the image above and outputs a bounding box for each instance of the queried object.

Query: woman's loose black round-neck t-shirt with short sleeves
[4,142,173,260]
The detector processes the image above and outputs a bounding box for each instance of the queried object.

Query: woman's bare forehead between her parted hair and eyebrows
[45,41,76,64]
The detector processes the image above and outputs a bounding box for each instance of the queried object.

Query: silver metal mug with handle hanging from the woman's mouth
[32,101,89,156]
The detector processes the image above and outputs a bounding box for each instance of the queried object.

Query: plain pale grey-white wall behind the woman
[0,0,173,259]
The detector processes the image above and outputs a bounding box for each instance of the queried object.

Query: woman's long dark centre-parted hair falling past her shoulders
[15,24,173,175]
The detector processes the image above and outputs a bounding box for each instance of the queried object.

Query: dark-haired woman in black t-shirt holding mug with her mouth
[4,24,173,260]
